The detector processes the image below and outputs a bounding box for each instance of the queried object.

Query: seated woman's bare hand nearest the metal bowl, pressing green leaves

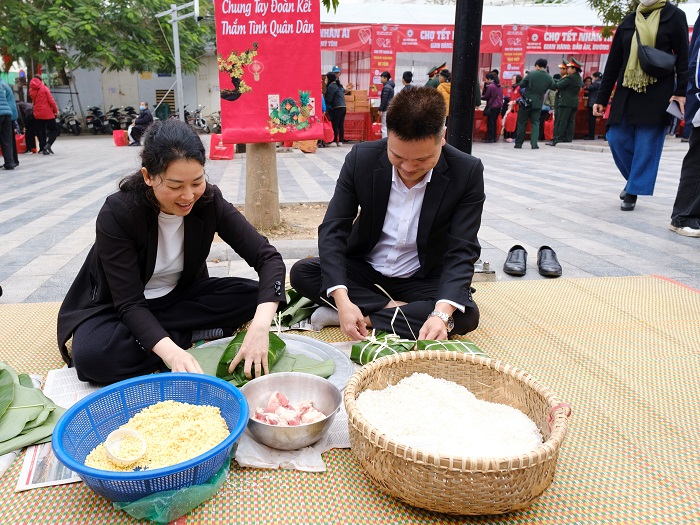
[228,303,279,379]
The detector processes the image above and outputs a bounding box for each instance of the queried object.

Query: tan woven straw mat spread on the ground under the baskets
[0,276,700,525]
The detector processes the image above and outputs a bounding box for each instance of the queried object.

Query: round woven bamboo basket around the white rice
[343,350,570,515]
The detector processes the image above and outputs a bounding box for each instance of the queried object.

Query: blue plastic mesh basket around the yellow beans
[51,373,249,502]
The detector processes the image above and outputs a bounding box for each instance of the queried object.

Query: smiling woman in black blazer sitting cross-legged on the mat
[58,120,285,383]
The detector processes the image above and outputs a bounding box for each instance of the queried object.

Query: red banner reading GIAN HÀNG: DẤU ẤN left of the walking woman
[526,26,612,55]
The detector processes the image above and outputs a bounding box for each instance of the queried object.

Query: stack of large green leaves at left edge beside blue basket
[0,362,65,455]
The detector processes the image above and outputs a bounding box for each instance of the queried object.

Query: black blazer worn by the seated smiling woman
[58,184,285,364]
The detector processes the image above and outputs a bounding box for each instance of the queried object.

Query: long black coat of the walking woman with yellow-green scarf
[595,3,688,126]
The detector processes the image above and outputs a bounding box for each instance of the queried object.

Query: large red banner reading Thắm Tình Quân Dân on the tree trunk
[214,0,323,143]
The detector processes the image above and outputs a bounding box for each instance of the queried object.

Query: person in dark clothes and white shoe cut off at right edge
[670,9,700,237]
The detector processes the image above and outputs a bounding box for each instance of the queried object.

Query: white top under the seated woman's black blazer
[143,212,185,299]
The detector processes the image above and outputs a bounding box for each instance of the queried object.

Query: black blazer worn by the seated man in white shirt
[318,139,485,306]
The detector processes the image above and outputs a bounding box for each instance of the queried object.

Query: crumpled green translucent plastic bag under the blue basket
[112,452,231,523]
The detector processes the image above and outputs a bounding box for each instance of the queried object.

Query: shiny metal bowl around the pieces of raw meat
[241,372,342,450]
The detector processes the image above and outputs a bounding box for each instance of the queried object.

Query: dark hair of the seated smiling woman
[119,119,213,211]
